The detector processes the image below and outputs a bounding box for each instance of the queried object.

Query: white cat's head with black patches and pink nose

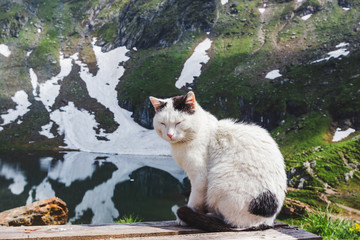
[150,92,200,143]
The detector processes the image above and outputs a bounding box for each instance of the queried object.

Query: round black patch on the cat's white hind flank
[249,190,279,217]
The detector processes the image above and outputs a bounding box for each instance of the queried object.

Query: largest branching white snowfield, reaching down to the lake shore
[40,39,170,155]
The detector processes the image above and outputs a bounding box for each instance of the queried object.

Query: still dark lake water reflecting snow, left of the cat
[0,152,189,224]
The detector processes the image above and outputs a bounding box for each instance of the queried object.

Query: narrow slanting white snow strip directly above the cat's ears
[175,38,212,89]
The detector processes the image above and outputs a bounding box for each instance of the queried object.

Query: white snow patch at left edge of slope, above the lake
[0,90,31,127]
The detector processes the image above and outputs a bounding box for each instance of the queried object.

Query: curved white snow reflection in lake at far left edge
[0,162,27,195]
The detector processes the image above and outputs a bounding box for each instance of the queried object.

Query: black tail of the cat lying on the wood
[177,206,234,232]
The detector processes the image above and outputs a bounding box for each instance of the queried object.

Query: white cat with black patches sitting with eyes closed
[150,91,287,231]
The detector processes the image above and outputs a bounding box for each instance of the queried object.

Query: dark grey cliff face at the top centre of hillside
[116,0,218,49]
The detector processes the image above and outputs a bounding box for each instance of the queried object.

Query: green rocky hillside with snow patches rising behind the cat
[0,0,360,219]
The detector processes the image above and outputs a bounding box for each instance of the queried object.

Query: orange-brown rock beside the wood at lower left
[0,197,68,226]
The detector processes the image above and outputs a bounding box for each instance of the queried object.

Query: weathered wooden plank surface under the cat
[0,221,321,240]
